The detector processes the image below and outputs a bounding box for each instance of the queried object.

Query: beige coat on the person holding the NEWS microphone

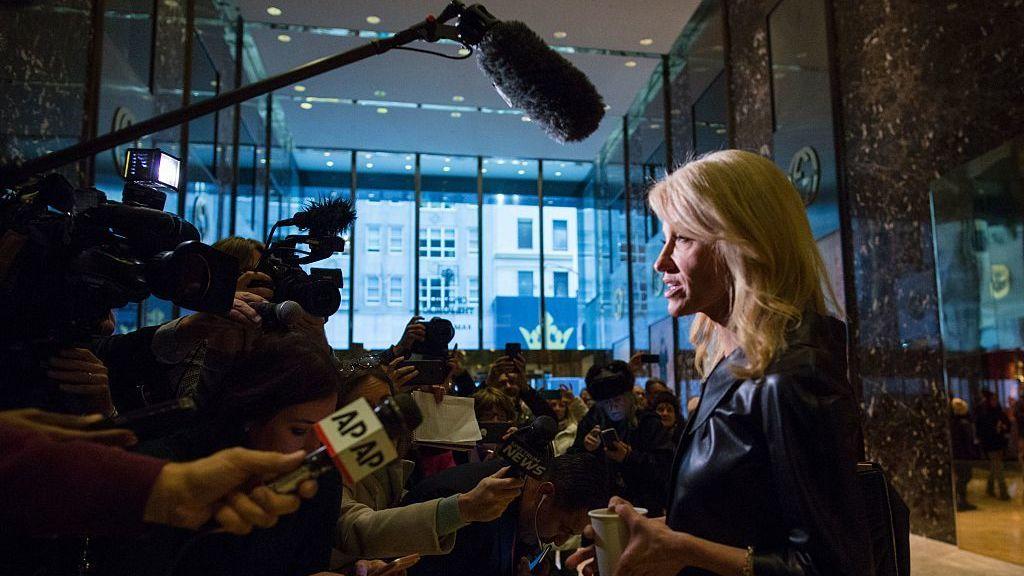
[331,460,455,568]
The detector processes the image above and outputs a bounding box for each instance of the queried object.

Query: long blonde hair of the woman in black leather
[648,150,840,378]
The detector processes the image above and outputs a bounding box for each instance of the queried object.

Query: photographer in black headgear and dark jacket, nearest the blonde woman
[569,360,673,517]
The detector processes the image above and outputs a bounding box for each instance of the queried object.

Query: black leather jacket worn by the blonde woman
[667,314,873,576]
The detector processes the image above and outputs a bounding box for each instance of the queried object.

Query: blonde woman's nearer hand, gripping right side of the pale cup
[608,496,690,576]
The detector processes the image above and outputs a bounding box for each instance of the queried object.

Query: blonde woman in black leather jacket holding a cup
[570,150,873,576]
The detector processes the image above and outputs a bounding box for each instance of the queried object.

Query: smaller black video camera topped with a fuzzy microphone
[256,198,355,318]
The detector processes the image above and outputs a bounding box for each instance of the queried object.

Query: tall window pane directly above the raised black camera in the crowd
[418,154,480,349]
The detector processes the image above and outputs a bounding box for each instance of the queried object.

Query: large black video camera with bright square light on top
[0,149,239,405]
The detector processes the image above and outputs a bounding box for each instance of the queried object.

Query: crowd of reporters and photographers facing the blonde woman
[0,233,678,576]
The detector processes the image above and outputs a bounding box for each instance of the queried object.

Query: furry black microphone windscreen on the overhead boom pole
[477,20,604,142]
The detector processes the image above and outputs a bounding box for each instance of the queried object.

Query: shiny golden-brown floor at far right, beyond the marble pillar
[956,462,1024,569]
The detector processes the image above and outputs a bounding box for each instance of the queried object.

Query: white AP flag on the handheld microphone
[313,398,398,485]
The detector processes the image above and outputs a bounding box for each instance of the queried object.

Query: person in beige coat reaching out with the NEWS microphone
[331,368,522,566]
